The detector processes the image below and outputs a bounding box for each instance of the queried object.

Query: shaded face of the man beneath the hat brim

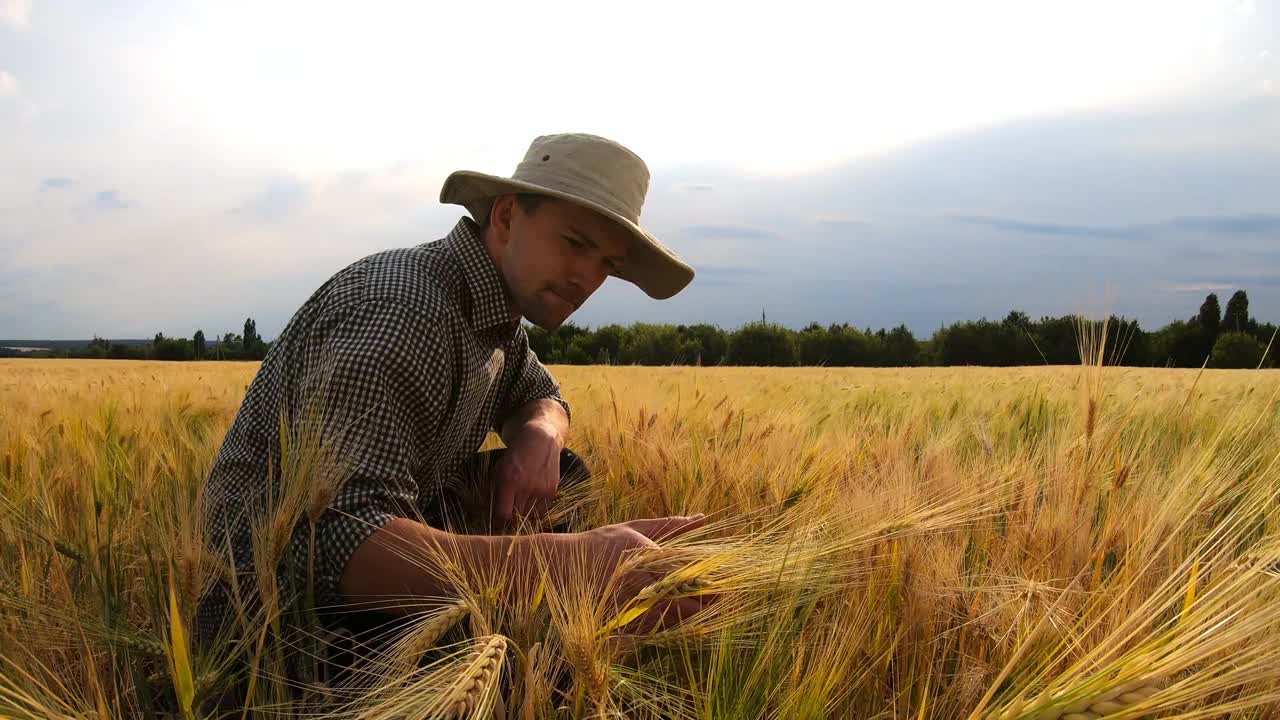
[488,195,628,329]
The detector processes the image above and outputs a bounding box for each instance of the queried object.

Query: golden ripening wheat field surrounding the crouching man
[0,345,1280,720]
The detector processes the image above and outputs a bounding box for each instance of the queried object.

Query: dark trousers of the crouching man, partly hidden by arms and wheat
[312,448,591,684]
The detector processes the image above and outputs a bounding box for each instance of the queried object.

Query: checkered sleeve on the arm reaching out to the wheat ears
[289,301,453,607]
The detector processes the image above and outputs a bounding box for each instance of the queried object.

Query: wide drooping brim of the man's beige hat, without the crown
[440,170,694,300]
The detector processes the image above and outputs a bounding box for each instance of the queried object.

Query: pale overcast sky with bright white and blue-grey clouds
[0,0,1280,340]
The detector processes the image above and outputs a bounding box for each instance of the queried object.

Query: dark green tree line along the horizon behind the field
[10,290,1276,368]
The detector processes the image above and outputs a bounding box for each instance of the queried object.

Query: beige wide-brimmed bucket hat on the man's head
[440,133,694,300]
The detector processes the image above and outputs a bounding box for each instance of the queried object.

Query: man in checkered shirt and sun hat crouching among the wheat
[198,135,701,671]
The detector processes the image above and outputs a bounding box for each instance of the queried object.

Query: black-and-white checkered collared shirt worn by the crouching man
[198,218,568,638]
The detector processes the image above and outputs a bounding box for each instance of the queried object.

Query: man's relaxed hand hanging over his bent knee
[490,425,563,530]
